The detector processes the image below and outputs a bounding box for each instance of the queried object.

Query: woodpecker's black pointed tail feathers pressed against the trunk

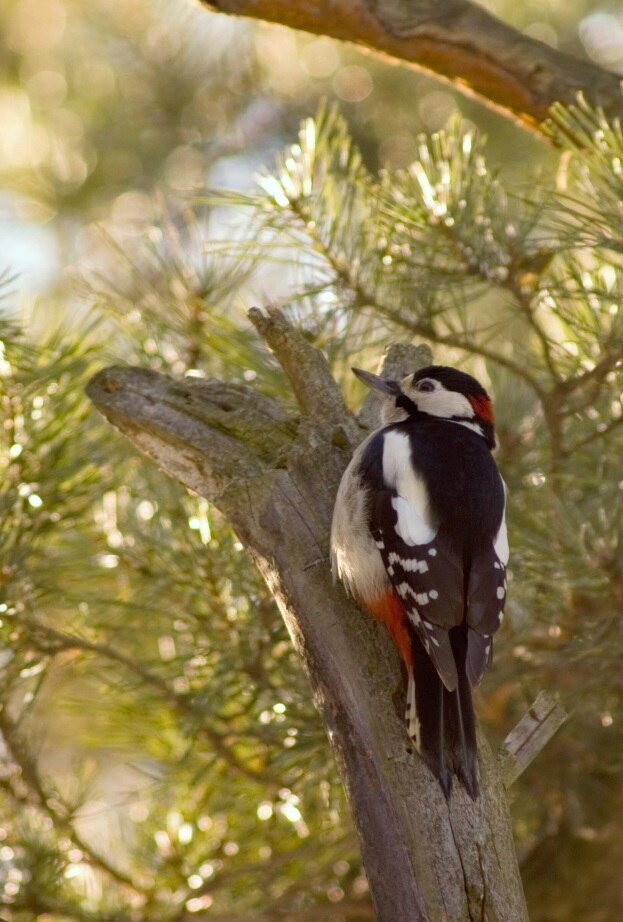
[406,626,478,800]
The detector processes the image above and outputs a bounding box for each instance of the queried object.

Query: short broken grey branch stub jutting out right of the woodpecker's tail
[498,692,569,788]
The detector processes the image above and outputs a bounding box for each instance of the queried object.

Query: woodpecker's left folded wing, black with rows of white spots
[369,489,465,691]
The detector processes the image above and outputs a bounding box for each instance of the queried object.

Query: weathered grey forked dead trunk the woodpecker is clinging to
[89,311,540,922]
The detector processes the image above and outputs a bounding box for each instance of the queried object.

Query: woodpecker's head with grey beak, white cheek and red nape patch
[353,365,495,449]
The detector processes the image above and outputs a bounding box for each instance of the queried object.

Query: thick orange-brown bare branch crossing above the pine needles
[208,0,623,127]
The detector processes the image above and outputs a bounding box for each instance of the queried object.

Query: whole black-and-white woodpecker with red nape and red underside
[331,365,508,800]
